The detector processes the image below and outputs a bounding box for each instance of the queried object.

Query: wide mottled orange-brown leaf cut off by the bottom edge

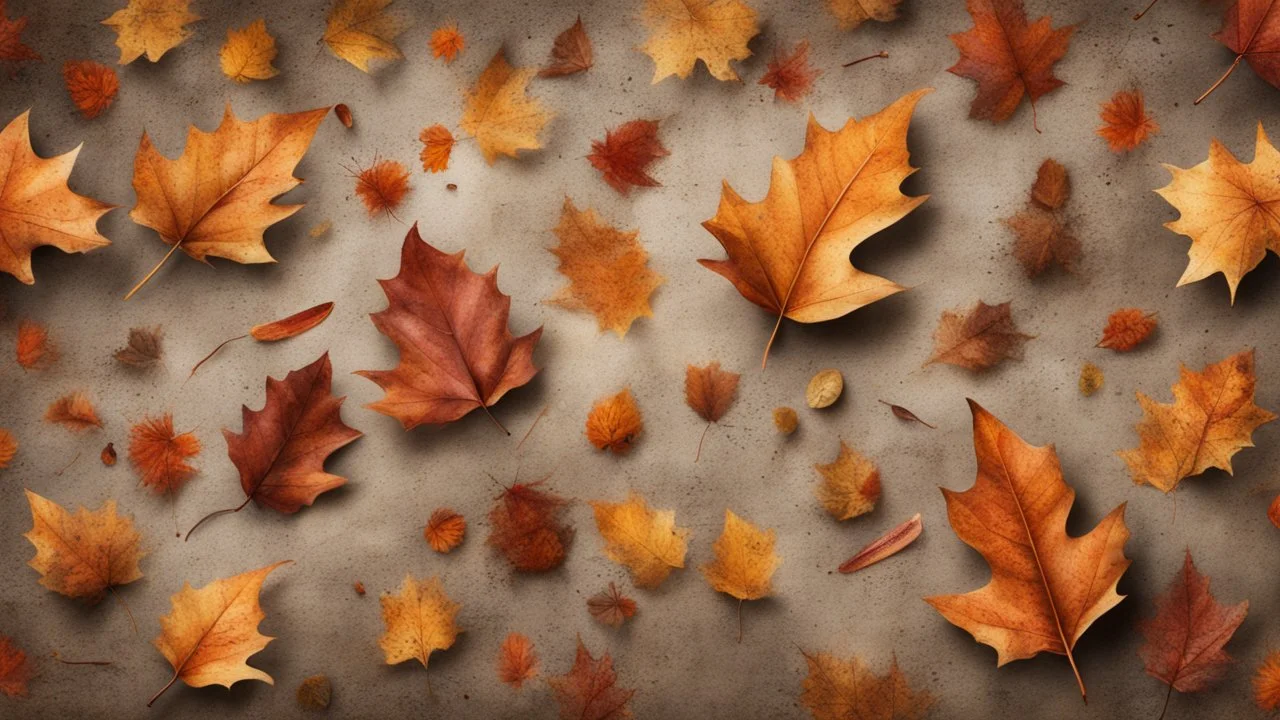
[800,652,933,720]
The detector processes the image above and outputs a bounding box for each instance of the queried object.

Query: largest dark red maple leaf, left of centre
[356,224,543,434]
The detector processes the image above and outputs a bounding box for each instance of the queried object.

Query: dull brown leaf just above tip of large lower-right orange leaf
[925,300,1034,373]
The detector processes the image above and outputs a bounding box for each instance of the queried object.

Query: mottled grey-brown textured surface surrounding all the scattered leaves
[0,0,1280,719]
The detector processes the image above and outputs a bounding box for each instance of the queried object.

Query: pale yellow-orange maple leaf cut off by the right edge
[1156,121,1280,304]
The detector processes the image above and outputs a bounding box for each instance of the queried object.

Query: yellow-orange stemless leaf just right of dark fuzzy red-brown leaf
[591,492,689,588]
